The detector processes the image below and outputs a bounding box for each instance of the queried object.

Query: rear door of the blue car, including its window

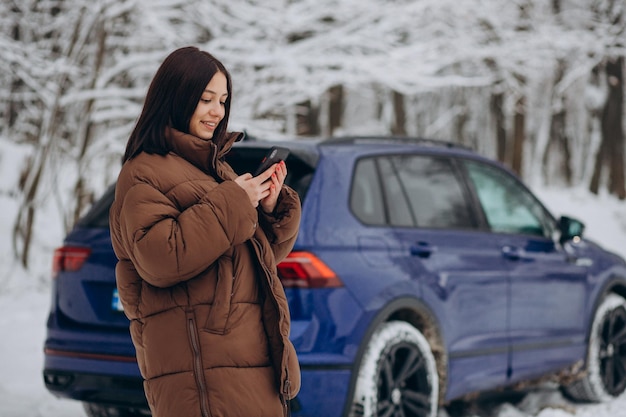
[370,154,508,398]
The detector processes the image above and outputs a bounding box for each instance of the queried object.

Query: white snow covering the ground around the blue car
[0,185,626,417]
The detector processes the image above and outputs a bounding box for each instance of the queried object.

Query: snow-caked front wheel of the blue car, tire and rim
[564,294,626,402]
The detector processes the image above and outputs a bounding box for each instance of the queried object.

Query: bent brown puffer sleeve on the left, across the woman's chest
[119,181,258,287]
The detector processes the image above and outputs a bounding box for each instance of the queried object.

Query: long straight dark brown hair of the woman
[123,46,232,162]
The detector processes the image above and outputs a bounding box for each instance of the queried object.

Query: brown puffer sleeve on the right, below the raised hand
[259,185,302,263]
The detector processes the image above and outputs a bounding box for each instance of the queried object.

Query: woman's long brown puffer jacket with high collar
[110,130,300,417]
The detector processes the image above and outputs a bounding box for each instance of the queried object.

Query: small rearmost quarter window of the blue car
[350,158,386,226]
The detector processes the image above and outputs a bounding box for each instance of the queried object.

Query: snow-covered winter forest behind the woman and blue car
[0,0,626,274]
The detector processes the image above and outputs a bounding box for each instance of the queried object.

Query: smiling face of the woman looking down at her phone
[189,72,228,140]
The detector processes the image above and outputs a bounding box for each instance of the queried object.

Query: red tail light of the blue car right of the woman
[278,252,343,288]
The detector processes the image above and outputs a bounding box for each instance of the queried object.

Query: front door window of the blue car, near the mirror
[464,160,552,237]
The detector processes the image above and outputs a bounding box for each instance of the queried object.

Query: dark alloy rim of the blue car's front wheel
[599,307,626,396]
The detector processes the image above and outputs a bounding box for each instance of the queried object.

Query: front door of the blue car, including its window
[465,160,587,381]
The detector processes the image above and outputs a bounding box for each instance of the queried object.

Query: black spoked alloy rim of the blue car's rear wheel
[376,343,432,417]
